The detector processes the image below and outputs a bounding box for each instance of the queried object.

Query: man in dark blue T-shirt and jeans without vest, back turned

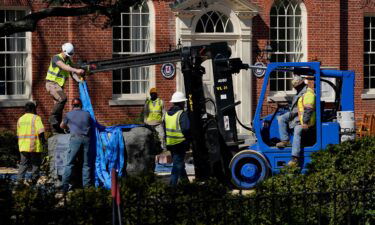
[60,98,92,192]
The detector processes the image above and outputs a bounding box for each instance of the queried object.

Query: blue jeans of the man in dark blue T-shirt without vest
[62,134,91,190]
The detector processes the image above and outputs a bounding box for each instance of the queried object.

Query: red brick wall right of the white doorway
[253,0,375,123]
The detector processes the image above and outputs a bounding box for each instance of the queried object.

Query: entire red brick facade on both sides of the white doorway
[0,0,375,132]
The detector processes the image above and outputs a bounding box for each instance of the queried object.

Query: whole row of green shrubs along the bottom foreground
[0,138,375,225]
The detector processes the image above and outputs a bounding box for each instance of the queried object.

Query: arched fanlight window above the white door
[195,11,233,33]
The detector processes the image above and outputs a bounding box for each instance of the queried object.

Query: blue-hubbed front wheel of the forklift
[229,150,270,189]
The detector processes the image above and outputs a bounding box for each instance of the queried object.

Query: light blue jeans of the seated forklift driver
[277,112,302,157]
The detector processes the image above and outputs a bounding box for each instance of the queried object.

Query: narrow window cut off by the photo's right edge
[363,16,375,90]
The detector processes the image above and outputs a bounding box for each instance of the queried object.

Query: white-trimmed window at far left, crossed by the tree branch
[0,9,31,99]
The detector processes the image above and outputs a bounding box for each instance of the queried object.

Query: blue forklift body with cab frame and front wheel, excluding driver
[229,62,355,189]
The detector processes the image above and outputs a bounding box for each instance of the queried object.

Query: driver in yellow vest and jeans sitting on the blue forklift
[276,76,315,167]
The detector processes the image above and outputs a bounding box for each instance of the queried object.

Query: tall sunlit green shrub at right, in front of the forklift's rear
[257,138,375,224]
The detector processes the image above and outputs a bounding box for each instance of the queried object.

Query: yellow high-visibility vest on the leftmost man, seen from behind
[17,113,44,152]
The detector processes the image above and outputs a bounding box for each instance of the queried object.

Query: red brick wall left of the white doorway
[0,0,176,129]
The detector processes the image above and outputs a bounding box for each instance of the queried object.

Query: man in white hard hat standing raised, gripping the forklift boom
[46,43,84,133]
